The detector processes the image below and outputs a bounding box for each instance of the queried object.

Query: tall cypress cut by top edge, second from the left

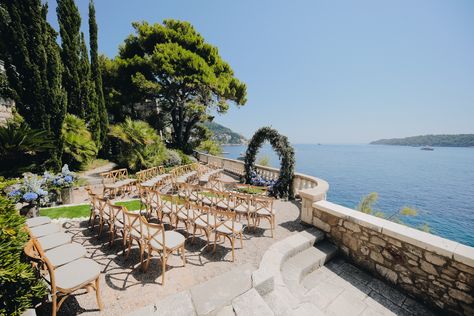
[56,0,85,118]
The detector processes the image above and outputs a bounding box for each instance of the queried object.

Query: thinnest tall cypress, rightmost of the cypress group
[89,0,109,147]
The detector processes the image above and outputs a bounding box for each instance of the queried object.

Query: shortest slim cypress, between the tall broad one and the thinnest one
[79,33,100,143]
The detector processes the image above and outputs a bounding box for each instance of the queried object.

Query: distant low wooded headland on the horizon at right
[370,134,474,147]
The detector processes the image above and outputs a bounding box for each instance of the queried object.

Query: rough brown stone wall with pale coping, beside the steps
[312,201,474,315]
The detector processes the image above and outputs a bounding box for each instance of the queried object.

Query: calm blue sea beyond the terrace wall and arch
[223,144,474,246]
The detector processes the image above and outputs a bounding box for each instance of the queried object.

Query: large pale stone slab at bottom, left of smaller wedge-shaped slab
[190,264,254,315]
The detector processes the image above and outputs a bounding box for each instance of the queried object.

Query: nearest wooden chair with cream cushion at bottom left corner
[24,239,103,316]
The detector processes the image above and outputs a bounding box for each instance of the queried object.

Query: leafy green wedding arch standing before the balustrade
[245,127,295,199]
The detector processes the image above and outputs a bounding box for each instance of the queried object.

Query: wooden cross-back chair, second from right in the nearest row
[211,208,244,261]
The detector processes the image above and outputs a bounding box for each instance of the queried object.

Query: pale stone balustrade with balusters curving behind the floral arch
[196,152,329,199]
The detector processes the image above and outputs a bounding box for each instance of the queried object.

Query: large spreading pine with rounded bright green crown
[106,20,246,151]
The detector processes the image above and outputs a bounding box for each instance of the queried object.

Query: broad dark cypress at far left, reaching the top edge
[0,0,66,169]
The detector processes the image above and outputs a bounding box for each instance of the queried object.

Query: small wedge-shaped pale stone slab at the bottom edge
[232,288,274,316]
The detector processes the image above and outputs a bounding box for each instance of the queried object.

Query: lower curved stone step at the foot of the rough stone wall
[281,240,337,296]
